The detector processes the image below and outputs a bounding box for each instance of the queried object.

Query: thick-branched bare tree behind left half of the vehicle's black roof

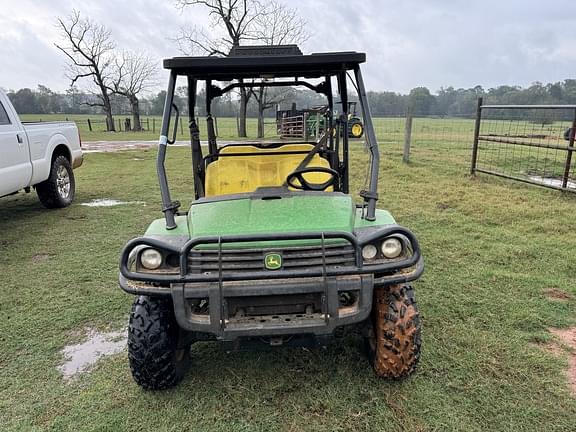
[176,0,262,137]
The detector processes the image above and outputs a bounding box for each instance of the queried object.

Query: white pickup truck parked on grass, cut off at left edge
[0,90,82,208]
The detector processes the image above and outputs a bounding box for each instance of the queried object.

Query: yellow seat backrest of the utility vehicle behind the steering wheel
[206,144,332,196]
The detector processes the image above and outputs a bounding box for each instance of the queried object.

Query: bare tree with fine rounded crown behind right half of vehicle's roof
[251,0,309,138]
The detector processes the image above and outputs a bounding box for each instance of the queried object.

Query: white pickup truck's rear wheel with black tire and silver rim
[36,156,76,208]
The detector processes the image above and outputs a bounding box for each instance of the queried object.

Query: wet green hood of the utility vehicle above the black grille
[188,193,355,237]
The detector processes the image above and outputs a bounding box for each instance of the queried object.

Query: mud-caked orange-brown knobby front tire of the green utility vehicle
[366,285,421,379]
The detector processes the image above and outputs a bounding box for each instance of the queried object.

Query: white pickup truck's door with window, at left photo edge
[0,100,32,196]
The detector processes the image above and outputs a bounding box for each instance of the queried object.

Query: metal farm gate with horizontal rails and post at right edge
[471,98,576,192]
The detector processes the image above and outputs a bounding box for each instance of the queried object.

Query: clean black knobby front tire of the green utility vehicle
[128,296,190,390]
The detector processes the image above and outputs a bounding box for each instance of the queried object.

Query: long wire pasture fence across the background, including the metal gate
[27,104,576,192]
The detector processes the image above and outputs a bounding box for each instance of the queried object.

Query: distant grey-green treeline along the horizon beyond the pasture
[8,79,576,117]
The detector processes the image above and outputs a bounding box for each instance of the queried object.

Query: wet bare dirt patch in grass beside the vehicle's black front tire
[58,329,126,381]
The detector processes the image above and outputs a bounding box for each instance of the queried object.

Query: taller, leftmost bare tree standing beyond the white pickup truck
[55,10,116,131]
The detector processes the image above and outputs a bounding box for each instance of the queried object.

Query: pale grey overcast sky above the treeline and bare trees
[0,0,576,92]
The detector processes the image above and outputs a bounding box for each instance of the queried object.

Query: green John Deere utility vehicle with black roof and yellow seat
[119,45,424,389]
